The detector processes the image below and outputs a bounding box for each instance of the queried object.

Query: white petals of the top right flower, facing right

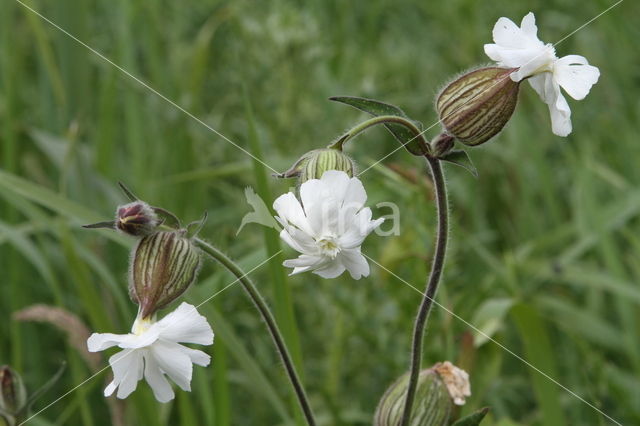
[484,12,600,136]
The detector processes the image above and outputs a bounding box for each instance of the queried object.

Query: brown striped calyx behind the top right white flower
[436,67,520,145]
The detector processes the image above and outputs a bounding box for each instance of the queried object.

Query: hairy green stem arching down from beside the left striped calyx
[194,238,316,426]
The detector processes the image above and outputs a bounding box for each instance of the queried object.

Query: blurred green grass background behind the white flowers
[0,0,640,426]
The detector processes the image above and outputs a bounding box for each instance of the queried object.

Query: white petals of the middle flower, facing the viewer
[273,170,384,279]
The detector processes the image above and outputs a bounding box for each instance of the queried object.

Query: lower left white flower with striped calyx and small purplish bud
[82,196,213,402]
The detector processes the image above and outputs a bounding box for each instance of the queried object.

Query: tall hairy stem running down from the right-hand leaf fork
[401,157,449,426]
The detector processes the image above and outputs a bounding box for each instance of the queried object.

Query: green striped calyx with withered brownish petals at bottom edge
[373,361,471,426]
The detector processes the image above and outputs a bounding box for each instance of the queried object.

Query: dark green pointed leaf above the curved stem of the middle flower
[329,96,429,157]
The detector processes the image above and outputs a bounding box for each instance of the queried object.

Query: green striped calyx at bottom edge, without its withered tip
[373,364,462,426]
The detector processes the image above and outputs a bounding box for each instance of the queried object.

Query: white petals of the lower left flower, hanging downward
[87,303,213,402]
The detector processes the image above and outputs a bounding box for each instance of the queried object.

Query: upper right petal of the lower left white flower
[153,302,213,345]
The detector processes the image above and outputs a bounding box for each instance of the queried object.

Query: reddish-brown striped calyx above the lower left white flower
[129,231,200,318]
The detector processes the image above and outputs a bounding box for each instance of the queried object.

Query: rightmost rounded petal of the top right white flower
[553,55,600,100]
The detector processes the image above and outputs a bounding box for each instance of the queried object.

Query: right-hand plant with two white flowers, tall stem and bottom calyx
[256,13,599,426]
